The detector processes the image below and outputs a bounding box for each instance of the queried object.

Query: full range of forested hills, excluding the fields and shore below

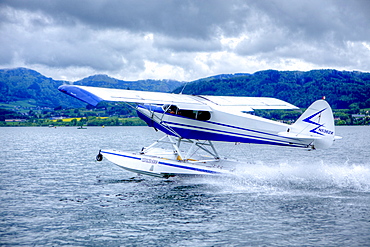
[0,68,370,109]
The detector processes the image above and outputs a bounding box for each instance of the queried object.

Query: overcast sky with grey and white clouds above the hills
[0,0,370,81]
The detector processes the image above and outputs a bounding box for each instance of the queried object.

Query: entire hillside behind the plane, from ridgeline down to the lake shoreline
[0,68,370,126]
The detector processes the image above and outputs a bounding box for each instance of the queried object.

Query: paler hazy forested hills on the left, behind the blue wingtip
[0,68,182,108]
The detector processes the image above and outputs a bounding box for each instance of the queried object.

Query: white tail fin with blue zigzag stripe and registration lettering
[279,100,341,149]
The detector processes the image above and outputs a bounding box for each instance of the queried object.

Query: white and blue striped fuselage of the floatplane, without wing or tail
[137,105,309,148]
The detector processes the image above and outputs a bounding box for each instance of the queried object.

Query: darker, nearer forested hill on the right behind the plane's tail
[175,70,370,109]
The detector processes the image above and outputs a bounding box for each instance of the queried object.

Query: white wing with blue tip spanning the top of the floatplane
[58,85,299,111]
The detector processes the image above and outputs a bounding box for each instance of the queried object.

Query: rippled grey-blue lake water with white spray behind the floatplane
[0,126,370,246]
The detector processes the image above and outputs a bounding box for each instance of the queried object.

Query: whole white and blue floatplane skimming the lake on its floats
[58,85,340,178]
